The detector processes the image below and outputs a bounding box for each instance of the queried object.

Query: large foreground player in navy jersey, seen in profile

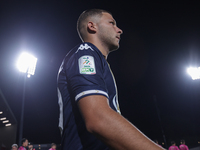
[58,9,163,150]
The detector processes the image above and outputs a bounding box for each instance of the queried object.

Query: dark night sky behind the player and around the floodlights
[0,0,200,146]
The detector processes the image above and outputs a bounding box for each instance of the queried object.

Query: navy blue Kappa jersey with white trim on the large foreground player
[58,43,120,150]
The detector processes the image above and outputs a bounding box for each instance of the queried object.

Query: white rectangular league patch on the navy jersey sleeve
[78,55,96,74]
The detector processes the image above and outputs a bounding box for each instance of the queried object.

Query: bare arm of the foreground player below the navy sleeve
[78,95,166,150]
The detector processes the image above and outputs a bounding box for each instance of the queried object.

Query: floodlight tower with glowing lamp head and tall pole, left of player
[17,52,37,145]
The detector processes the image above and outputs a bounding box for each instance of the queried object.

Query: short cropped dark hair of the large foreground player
[77,9,112,40]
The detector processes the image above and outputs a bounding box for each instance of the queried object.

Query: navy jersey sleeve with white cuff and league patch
[65,45,108,101]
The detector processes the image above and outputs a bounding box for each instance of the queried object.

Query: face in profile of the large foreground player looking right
[97,13,122,51]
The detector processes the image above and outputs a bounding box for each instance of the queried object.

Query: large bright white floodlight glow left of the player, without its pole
[17,52,37,77]
